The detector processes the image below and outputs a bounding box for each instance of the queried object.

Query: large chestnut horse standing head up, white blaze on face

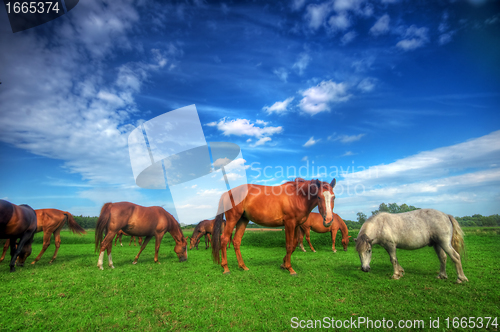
[212,178,335,275]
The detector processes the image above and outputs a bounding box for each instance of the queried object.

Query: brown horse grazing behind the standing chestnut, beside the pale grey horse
[299,212,350,252]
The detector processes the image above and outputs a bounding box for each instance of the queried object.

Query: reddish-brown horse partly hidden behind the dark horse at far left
[31,209,87,264]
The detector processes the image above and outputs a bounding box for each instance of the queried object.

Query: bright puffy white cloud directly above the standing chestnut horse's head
[299,81,352,115]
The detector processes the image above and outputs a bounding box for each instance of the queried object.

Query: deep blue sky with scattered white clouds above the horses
[0,0,500,220]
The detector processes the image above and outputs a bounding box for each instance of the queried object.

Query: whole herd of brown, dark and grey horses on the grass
[0,178,468,283]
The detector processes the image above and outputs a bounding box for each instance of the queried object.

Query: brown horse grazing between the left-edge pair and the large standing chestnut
[95,202,187,270]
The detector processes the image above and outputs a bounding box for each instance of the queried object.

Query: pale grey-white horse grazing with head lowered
[355,209,469,283]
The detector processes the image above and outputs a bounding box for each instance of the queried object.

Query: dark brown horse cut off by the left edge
[0,200,36,272]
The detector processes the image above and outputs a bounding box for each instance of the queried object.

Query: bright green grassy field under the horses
[0,228,500,331]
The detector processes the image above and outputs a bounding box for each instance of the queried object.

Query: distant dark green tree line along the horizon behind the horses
[64,203,500,229]
